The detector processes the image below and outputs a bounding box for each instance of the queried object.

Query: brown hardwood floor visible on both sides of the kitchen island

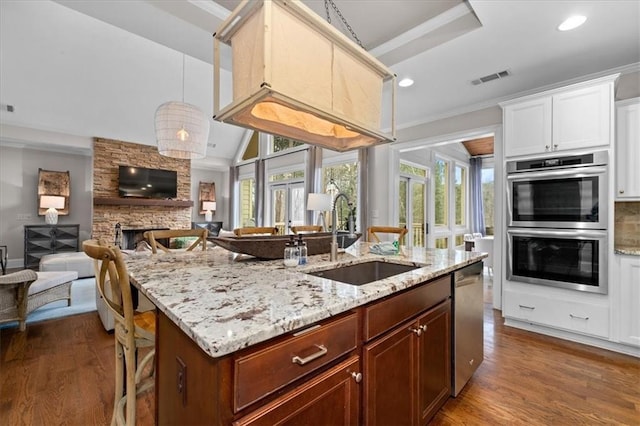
[0,305,640,425]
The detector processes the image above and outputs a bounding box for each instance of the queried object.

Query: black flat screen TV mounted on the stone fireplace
[118,166,178,200]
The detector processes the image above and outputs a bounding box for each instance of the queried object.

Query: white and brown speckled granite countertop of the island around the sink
[125,242,487,357]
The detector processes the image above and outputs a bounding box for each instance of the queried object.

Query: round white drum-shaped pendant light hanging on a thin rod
[155,54,209,160]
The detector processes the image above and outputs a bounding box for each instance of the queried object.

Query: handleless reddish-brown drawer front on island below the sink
[364,275,451,341]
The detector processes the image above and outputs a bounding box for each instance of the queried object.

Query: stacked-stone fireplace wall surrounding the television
[92,138,193,241]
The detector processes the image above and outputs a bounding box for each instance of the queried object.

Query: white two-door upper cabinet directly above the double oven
[501,75,617,157]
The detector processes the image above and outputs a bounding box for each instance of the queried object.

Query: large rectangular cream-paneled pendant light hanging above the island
[213,0,396,151]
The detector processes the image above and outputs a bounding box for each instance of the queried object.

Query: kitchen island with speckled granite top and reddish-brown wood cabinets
[126,243,486,425]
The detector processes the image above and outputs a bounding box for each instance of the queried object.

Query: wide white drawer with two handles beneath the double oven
[503,289,609,339]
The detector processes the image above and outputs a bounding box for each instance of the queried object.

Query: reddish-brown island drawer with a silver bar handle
[233,313,358,412]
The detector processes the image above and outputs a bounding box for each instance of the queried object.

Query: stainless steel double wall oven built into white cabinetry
[507,151,609,294]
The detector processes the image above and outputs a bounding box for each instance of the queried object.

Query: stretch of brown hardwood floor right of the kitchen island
[432,304,640,425]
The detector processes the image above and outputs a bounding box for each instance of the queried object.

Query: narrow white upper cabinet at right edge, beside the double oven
[616,98,640,201]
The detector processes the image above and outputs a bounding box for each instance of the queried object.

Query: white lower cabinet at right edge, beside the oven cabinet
[616,254,640,347]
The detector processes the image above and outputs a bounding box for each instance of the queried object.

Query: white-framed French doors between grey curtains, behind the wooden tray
[270,181,305,235]
